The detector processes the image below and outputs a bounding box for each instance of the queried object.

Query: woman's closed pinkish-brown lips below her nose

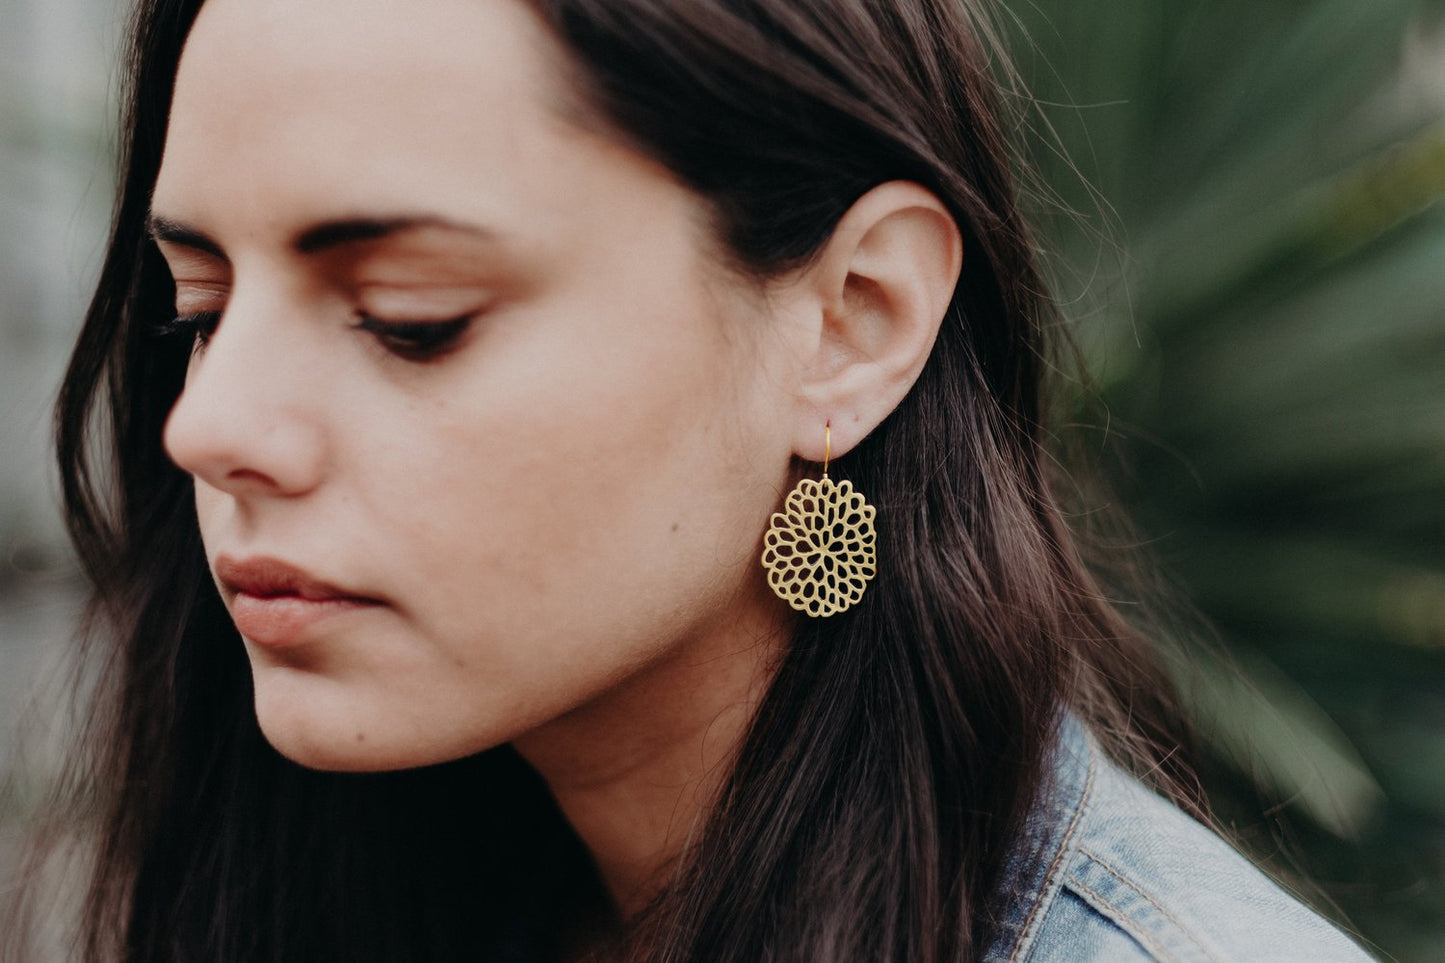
[215,555,383,648]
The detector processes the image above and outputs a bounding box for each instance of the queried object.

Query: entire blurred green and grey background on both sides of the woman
[0,0,1445,963]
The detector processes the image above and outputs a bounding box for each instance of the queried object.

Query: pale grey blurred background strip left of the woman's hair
[0,0,124,925]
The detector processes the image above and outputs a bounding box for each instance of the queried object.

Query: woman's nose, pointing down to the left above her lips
[163,295,325,497]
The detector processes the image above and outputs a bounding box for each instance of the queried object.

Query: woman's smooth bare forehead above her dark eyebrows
[155,0,585,223]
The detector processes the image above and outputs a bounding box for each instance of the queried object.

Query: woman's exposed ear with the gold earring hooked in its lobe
[792,181,962,461]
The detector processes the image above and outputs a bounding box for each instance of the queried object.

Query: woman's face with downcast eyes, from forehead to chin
[161,0,792,769]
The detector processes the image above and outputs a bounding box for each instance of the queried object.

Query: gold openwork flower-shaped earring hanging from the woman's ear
[763,421,877,617]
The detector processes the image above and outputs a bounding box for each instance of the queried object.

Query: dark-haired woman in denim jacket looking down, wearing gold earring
[0,0,1364,963]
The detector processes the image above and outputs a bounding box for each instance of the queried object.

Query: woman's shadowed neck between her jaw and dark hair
[514,592,786,918]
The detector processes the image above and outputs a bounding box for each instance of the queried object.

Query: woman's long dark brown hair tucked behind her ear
[9,0,1188,963]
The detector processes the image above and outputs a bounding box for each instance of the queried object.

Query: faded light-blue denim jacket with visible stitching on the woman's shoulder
[984,714,1371,963]
